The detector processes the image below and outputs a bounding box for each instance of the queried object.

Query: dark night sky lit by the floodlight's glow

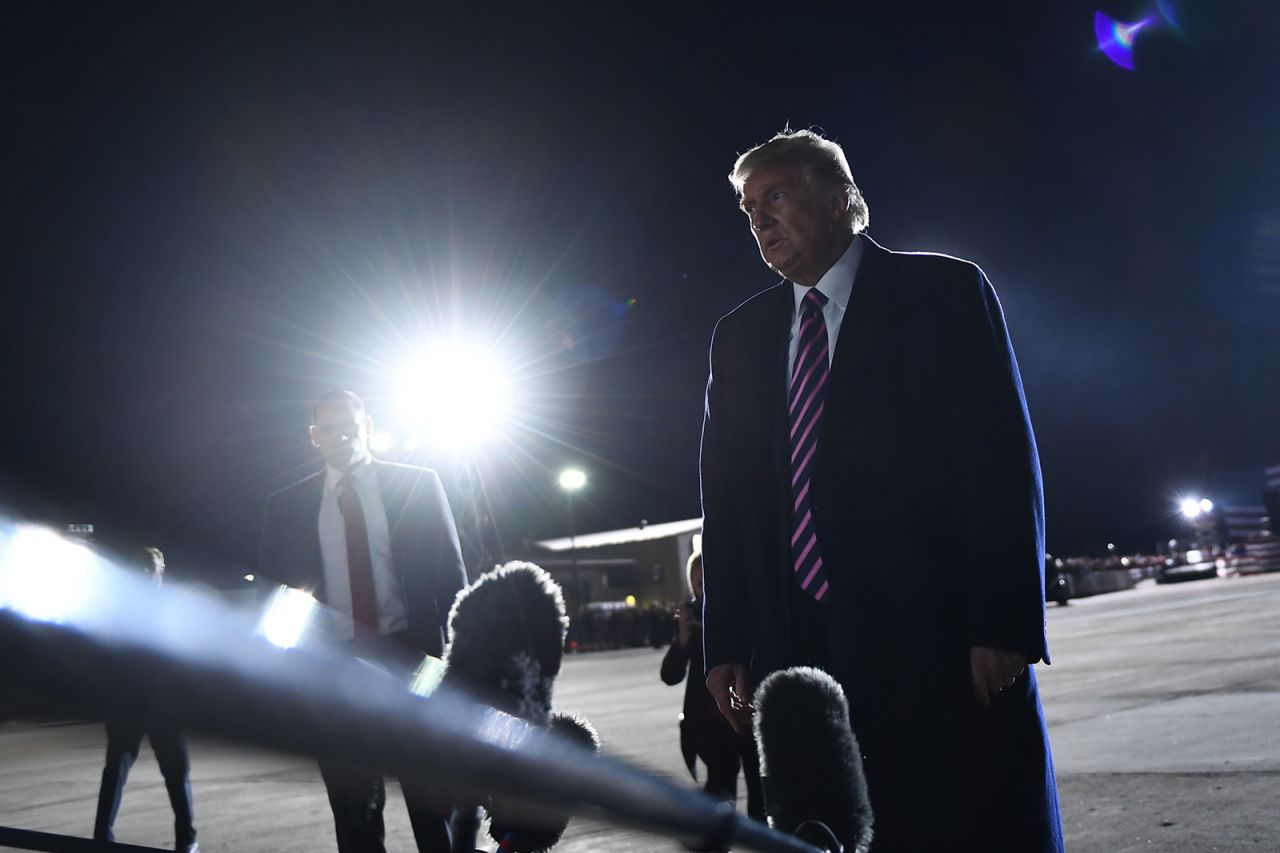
[0,0,1280,575]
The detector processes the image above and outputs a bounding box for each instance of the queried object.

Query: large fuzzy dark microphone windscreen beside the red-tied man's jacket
[444,562,568,725]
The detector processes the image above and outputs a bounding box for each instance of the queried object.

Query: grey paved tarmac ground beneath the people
[0,575,1280,853]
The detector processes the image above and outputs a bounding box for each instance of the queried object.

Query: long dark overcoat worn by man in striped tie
[701,236,1061,853]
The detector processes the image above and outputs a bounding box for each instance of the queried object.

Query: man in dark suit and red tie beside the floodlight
[259,391,467,853]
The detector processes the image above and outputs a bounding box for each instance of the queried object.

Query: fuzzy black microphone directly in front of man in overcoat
[754,666,872,853]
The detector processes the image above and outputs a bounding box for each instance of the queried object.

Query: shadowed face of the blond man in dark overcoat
[740,164,849,286]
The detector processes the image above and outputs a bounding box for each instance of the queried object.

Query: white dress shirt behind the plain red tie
[319,462,408,630]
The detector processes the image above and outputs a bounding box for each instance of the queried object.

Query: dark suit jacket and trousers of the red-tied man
[259,461,467,852]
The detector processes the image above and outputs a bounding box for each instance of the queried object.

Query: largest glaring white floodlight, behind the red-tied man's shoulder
[399,341,507,448]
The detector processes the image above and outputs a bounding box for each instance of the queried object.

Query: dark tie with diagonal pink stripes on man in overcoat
[787,287,831,601]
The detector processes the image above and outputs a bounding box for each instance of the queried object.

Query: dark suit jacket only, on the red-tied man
[259,461,467,657]
